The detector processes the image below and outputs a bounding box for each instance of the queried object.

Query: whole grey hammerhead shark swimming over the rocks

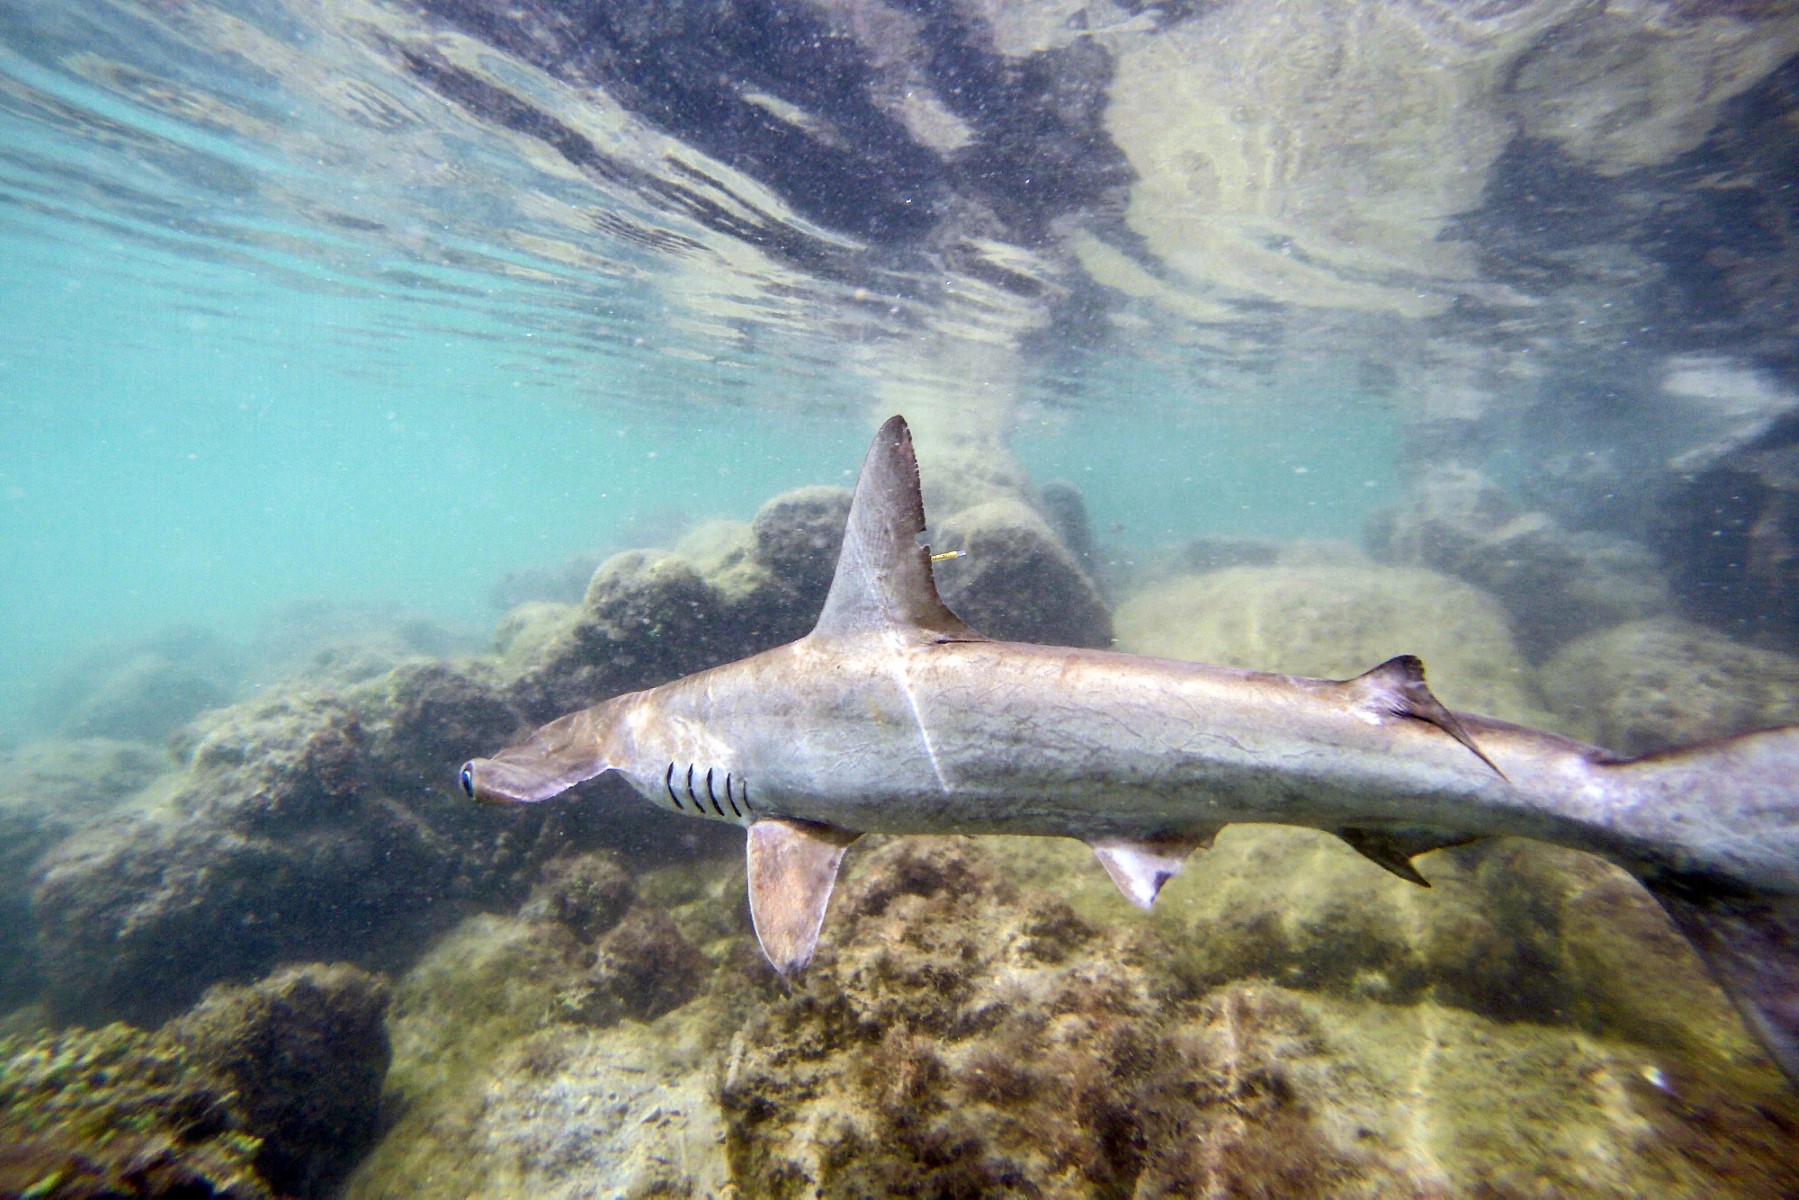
[461,417,1799,1083]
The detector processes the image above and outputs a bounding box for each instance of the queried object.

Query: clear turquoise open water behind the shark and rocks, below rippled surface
[0,210,1396,723]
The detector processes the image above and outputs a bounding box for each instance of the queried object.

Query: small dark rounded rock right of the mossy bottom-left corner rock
[162,963,390,1198]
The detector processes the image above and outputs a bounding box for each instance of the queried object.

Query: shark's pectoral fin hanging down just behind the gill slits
[748,817,862,975]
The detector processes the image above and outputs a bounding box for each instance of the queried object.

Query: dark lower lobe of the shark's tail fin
[1648,882,1799,1087]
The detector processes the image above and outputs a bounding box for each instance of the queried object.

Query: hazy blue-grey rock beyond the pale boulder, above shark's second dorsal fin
[1367,466,1669,657]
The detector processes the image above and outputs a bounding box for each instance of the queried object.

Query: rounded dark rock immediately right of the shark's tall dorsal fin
[932,498,1112,648]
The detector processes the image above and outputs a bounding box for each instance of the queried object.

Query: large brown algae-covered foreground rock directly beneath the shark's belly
[721,831,1799,1198]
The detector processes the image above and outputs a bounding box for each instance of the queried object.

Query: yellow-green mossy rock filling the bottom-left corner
[0,1025,277,1200]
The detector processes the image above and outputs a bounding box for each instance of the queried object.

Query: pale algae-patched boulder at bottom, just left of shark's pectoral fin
[345,856,741,1200]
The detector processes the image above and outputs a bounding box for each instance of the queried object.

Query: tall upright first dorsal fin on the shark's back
[813,417,979,639]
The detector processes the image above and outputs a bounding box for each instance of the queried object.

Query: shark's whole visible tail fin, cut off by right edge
[1605,725,1799,1085]
